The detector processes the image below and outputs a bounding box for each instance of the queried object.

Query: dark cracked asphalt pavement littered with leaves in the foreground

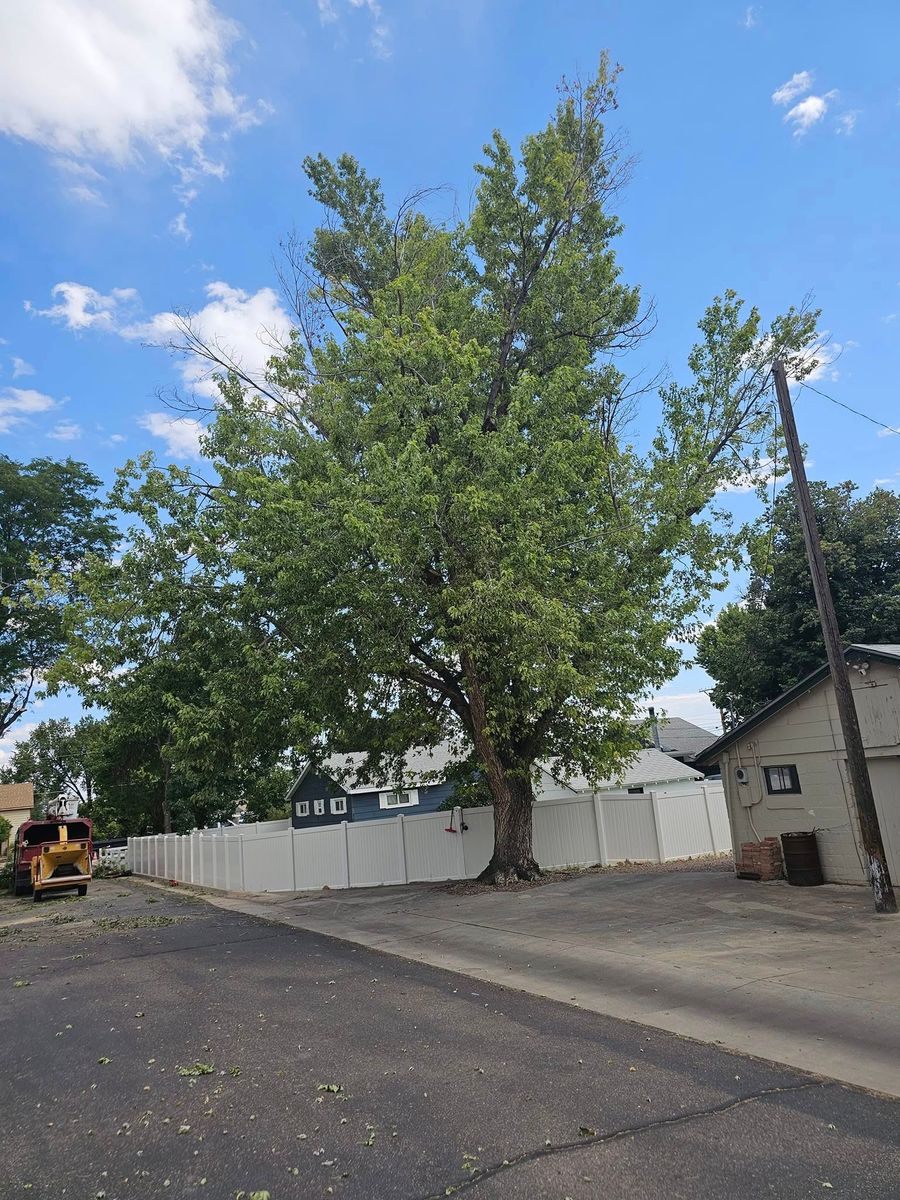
[0,881,900,1200]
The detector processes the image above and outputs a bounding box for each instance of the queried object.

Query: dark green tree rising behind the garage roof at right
[697,482,900,725]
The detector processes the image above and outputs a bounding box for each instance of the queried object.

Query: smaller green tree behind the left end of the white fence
[49,460,300,833]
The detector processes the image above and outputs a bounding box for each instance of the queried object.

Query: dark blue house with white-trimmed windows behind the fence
[287,745,454,829]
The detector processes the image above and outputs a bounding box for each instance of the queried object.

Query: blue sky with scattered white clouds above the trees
[0,0,900,751]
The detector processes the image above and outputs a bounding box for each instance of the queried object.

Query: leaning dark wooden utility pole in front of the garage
[772,359,896,912]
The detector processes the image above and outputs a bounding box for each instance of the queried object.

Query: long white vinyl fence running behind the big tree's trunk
[128,784,731,892]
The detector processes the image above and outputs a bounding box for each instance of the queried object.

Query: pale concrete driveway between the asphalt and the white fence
[208,871,900,1096]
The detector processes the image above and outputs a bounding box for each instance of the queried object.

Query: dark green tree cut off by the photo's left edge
[0,455,115,734]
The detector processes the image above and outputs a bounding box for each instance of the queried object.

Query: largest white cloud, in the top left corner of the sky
[0,0,262,189]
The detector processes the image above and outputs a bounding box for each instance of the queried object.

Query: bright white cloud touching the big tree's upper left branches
[120,280,290,398]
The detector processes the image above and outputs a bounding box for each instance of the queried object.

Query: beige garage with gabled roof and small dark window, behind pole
[698,646,900,883]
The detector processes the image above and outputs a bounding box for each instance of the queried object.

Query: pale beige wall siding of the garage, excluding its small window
[720,662,900,883]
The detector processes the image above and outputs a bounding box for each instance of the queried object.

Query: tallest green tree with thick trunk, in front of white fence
[77,64,815,882]
